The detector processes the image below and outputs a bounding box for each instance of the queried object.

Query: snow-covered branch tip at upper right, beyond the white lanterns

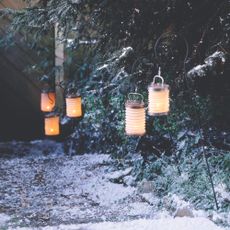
[187,51,226,78]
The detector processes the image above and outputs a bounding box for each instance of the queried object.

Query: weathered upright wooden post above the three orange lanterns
[54,24,65,110]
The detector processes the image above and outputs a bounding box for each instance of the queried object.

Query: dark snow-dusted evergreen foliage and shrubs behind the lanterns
[1,0,230,215]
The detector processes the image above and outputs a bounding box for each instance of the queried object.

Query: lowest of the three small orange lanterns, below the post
[45,113,60,136]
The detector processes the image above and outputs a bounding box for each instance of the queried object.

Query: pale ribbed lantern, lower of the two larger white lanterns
[125,93,146,136]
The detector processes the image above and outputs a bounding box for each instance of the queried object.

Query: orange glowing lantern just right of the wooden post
[66,96,82,118]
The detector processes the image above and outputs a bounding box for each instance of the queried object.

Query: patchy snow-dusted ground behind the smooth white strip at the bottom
[0,142,154,226]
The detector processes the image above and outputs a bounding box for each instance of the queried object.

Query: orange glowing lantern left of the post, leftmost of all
[41,90,56,112]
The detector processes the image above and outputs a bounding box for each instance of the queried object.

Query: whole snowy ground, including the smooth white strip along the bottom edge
[0,141,228,230]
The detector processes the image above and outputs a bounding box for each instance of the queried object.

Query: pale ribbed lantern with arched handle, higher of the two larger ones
[148,69,170,116]
